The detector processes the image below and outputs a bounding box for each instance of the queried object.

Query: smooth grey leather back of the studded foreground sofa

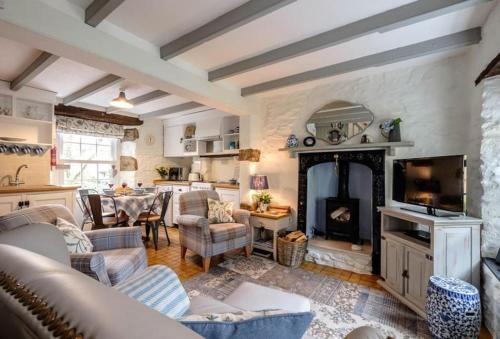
[0,245,200,339]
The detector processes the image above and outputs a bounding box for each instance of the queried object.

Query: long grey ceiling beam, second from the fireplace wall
[208,0,491,81]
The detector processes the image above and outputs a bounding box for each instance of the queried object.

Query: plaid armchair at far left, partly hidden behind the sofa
[0,205,147,286]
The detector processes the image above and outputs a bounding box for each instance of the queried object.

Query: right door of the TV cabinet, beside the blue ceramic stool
[405,247,432,310]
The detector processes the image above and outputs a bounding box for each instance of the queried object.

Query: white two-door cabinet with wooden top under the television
[378,207,482,318]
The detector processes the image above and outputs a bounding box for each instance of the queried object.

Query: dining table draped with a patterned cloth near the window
[101,193,159,226]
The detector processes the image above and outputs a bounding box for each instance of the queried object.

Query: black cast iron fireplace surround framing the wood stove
[297,150,385,274]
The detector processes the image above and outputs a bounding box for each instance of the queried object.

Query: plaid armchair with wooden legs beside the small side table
[177,191,252,272]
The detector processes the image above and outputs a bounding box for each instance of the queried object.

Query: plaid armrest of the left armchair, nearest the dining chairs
[85,226,144,251]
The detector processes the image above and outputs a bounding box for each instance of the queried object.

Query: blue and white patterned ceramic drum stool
[425,276,481,339]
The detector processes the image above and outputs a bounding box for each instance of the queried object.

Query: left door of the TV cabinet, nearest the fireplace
[385,239,404,295]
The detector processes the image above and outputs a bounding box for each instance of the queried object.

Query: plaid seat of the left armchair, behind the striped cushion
[99,247,148,286]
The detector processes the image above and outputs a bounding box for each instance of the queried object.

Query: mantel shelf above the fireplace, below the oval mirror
[279,141,415,158]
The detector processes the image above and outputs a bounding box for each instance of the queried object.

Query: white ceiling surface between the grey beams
[0,0,495,119]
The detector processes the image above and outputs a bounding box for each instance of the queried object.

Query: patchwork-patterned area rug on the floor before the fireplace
[184,255,430,339]
